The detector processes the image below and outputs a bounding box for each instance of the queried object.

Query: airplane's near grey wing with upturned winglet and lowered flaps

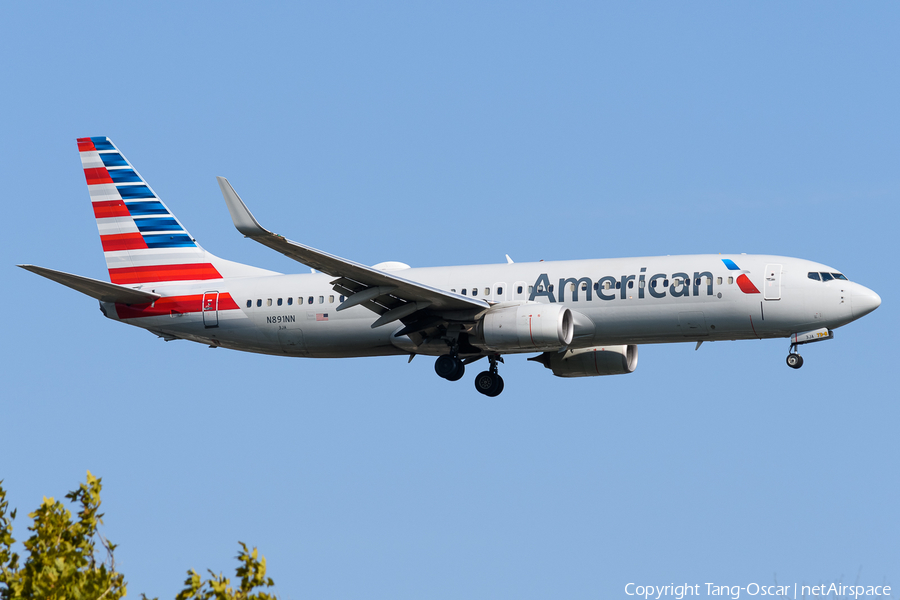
[216,177,490,333]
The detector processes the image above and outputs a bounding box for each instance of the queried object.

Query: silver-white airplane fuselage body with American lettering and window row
[103,254,880,357]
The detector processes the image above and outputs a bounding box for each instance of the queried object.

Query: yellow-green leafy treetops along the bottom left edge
[0,471,276,600]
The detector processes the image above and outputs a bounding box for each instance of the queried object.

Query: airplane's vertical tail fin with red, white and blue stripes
[78,137,274,285]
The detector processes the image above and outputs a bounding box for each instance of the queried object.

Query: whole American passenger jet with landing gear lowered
[18,137,881,397]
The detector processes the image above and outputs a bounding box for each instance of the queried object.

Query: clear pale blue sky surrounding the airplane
[0,2,900,599]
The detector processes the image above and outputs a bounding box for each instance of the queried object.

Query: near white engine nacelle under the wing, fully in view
[474,302,575,352]
